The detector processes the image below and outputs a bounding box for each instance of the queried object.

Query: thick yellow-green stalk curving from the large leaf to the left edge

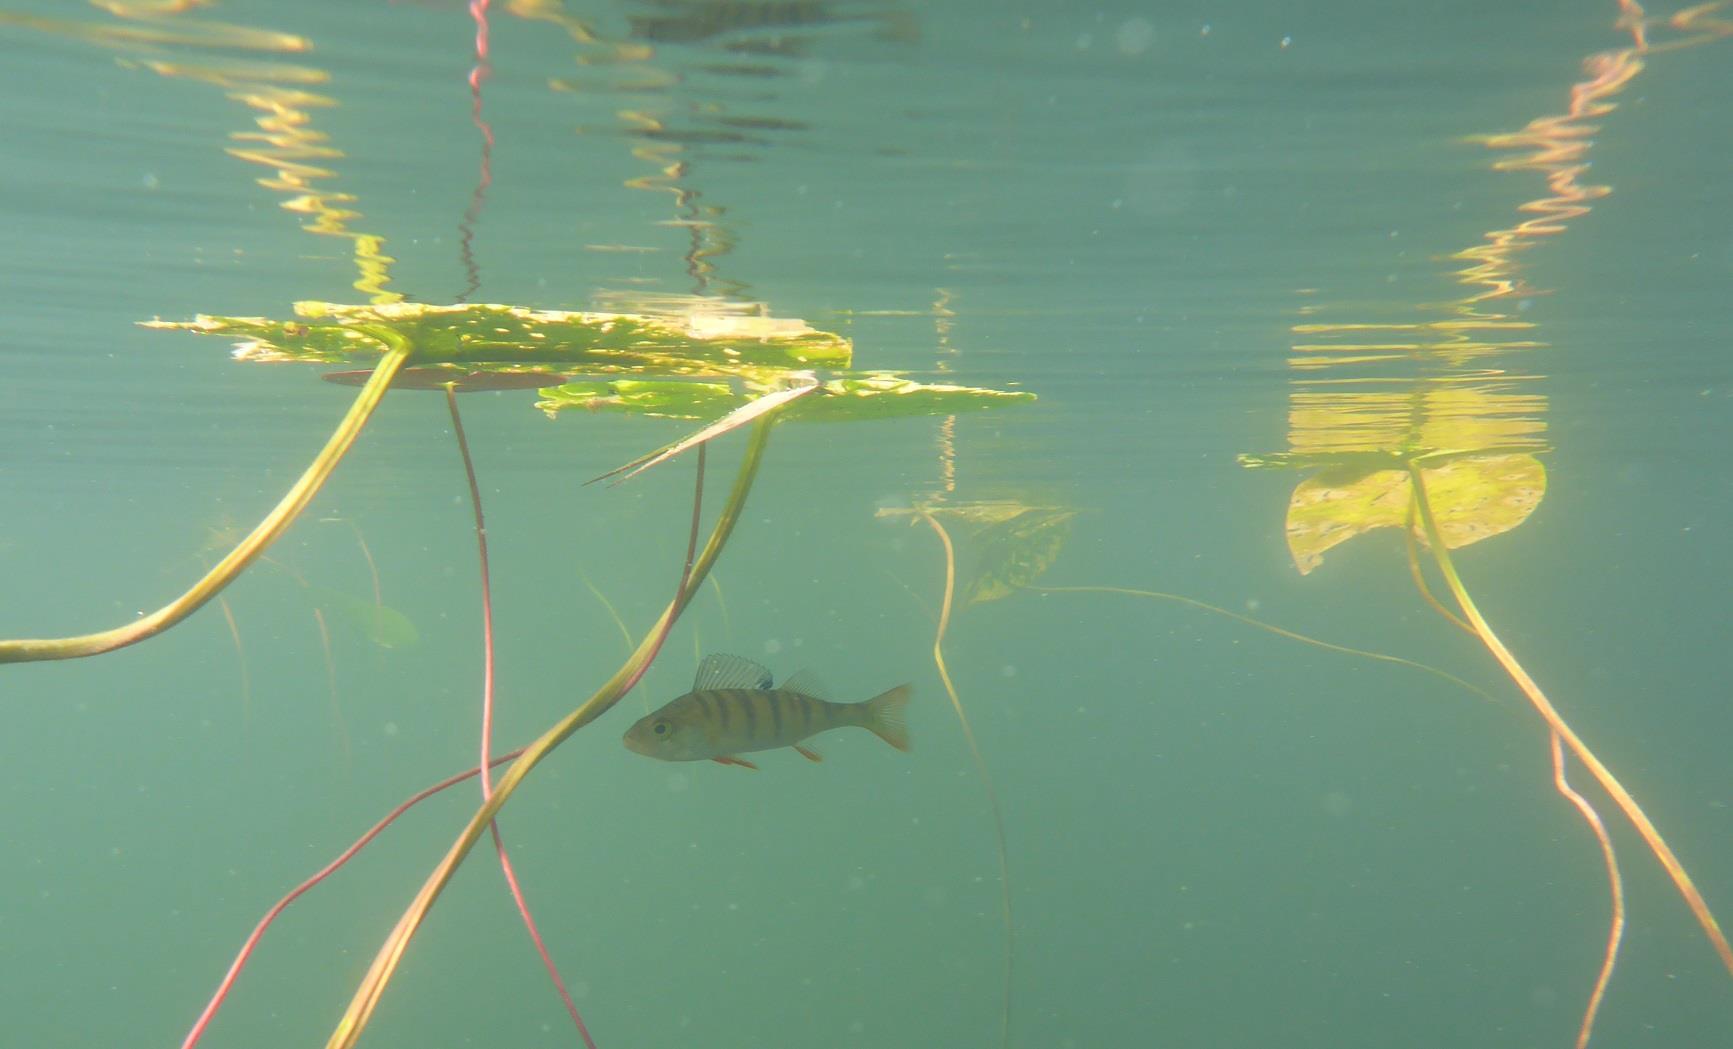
[0,343,412,662]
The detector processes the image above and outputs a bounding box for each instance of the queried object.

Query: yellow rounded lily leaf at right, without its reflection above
[1288,454,1546,576]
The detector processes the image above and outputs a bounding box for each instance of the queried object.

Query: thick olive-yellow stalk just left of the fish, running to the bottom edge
[326,416,775,1049]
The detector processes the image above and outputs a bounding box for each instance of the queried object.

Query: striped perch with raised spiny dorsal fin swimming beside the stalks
[626,654,910,768]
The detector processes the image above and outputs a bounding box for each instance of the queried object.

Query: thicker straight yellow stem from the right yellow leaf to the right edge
[1409,463,1733,974]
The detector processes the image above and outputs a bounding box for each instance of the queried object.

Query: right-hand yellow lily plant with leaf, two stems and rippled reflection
[1241,0,1733,1049]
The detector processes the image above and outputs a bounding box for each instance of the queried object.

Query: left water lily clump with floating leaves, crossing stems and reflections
[0,3,1033,1046]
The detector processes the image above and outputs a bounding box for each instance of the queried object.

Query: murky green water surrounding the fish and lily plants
[0,0,1733,1049]
